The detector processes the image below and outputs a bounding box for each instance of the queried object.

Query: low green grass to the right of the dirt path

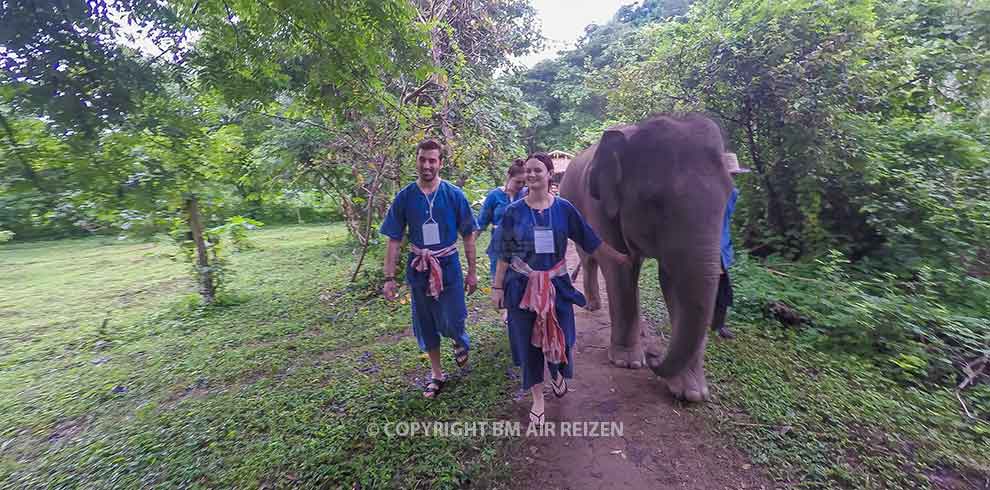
[641,262,990,489]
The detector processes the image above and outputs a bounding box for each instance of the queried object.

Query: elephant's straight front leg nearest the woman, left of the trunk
[601,260,646,369]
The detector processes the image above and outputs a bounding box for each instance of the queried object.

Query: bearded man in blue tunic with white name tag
[380,139,478,399]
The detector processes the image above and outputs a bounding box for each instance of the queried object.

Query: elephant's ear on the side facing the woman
[588,125,638,219]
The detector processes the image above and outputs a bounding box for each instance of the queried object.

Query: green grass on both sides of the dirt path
[0,225,990,489]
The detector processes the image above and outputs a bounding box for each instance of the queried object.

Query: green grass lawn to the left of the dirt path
[0,226,515,488]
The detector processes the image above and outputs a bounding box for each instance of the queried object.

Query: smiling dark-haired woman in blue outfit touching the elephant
[492,153,629,424]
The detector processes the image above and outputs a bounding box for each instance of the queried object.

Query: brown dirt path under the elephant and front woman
[512,247,774,490]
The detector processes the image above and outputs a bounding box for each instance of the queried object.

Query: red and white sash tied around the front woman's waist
[512,257,567,364]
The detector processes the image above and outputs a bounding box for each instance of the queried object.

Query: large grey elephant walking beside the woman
[560,114,732,402]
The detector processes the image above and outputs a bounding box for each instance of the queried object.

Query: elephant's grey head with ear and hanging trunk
[587,116,732,378]
